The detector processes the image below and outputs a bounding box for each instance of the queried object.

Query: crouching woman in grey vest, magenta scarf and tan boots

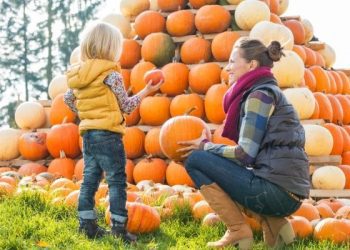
[179,39,310,249]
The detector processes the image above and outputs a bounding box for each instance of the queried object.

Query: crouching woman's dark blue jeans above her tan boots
[185,151,301,217]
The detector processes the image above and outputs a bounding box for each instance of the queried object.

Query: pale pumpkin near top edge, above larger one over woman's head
[235,0,270,30]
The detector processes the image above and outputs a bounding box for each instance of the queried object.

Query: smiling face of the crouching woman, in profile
[226,48,252,85]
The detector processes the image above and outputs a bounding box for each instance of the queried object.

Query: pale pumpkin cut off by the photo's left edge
[0,128,21,161]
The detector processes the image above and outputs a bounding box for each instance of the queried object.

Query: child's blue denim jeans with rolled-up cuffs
[78,130,128,223]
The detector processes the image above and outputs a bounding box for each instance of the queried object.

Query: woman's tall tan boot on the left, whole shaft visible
[200,183,253,250]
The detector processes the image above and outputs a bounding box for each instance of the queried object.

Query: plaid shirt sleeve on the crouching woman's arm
[203,90,275,165]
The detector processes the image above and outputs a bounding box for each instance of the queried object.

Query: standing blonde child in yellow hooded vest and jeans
[64,22,162,242]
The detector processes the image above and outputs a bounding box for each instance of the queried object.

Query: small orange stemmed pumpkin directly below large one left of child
[47,151,75,179]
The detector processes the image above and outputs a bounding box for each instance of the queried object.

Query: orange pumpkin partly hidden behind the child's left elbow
[49,94,76,125]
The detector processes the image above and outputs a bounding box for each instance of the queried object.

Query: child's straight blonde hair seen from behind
[80,21,123,61]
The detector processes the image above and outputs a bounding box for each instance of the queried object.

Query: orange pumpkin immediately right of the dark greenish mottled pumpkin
[180,37,212,64]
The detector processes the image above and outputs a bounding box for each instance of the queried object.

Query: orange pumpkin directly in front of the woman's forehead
[211,31,241,62]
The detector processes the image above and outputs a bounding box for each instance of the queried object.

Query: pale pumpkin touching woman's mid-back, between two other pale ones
[303,124,333,156]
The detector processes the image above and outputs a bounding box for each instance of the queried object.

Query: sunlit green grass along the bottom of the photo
[0,193,350,250]
